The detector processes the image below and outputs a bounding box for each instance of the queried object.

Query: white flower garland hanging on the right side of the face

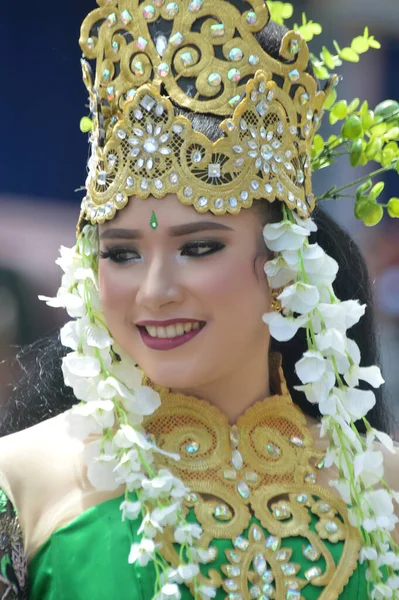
[263,207,399,600]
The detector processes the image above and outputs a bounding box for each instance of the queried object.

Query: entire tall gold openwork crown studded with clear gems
[80,0,329,223]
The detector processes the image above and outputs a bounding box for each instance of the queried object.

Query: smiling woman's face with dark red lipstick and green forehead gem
[99,195,270,390]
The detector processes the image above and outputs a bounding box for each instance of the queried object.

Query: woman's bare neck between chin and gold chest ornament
[173,346,270,425]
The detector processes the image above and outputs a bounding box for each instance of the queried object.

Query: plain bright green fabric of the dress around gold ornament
[28,498,367,600]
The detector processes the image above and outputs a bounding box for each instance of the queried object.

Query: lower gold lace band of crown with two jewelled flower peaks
[82,71,328,224]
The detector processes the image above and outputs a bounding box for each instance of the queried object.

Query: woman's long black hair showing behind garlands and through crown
[0,22,393,436]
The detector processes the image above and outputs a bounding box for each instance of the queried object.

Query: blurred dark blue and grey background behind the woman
[0,0,399,426]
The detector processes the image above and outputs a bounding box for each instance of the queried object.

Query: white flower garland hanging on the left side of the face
[40,225,216,600]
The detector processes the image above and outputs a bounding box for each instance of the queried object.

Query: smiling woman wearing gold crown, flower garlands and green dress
[0,1,398,600]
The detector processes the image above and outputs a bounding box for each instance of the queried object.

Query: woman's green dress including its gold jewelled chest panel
[0,368,367,600]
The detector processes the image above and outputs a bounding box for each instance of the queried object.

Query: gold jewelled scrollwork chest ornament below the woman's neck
[144,360,360,600]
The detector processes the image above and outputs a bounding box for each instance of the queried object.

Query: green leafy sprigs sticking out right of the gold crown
[267,0,399,227]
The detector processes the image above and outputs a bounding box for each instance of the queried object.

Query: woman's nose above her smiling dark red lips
[136,257,183,311]
